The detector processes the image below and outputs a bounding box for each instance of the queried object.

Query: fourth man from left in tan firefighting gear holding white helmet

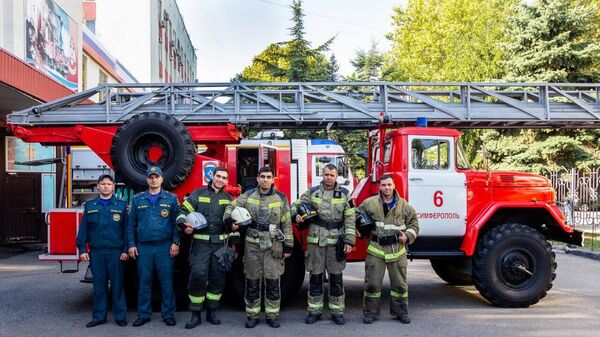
[223,166,294,328]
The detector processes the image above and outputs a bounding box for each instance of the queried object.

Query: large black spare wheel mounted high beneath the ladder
[110,112,196,190]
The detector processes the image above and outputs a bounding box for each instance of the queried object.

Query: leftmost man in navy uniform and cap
[77,174,128,328]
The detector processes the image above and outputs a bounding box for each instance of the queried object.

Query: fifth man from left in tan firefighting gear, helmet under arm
[292,164,356,325]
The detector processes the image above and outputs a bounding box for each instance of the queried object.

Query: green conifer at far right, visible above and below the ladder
[486,0,600,173]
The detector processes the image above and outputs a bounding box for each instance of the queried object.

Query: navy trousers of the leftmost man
[90,249,127,321]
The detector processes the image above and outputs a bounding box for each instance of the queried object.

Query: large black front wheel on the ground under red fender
[473,223,556,308]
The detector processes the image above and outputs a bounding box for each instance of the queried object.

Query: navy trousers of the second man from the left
[137,241,175,319]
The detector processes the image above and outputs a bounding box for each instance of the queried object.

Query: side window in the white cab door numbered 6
[411,139,450,170]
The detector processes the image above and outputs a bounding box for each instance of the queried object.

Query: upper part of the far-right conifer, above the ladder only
[505,0,600,82]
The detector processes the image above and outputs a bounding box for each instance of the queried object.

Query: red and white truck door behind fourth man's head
[258,144,294,202]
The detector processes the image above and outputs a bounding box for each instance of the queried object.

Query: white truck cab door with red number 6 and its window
[407,136,467,236]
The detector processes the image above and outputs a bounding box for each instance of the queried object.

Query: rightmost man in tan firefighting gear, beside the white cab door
[357,174,419,324]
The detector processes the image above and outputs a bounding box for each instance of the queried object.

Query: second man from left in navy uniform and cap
[127,166,185,327]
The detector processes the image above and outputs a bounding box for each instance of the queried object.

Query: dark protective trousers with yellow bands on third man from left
[188,240,225,311]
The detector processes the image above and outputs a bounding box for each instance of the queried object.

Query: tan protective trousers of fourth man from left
[244,241,284,318]
